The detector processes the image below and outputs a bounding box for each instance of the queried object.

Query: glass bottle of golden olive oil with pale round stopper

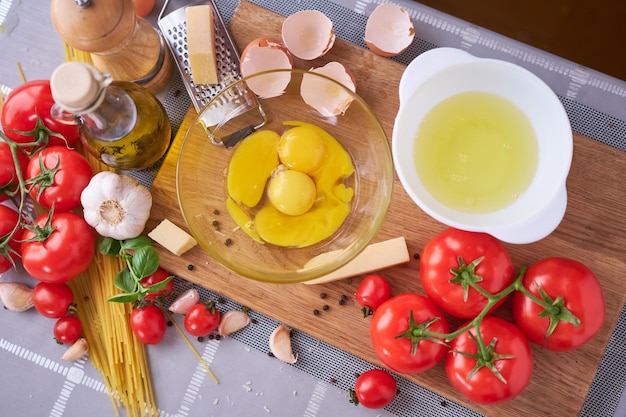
[50,62,171,170]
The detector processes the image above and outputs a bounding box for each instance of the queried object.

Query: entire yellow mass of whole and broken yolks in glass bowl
[227,122,354,247]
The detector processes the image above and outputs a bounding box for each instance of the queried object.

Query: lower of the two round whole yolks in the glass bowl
[267,169,316,216]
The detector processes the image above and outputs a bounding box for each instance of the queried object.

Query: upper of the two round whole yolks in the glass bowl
[278,126,326,174]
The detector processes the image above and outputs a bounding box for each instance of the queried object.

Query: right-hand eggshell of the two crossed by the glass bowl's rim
[300,62,356,117]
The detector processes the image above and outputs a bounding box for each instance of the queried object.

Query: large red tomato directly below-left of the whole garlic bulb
[22,211,96,283]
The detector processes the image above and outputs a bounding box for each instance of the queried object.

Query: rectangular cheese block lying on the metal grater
[185,5,219,85]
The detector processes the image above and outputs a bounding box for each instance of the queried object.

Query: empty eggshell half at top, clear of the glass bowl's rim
[282,10,335,60]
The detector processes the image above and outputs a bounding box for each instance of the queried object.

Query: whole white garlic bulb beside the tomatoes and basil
[80,171,152,240]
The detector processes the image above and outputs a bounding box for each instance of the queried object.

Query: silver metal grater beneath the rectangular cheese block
[158,0,267,147]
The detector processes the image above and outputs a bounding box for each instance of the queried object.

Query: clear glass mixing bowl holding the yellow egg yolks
[176,69,394,283]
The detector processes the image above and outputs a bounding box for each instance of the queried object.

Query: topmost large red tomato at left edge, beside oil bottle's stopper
[0,80,79,148]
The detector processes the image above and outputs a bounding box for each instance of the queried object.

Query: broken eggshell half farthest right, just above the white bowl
[364,3,415,56]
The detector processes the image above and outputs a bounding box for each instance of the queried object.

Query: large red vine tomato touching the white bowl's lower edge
[420,228,514,319]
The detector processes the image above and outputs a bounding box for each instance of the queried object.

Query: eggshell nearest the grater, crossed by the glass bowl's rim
[240,38,293,98]
